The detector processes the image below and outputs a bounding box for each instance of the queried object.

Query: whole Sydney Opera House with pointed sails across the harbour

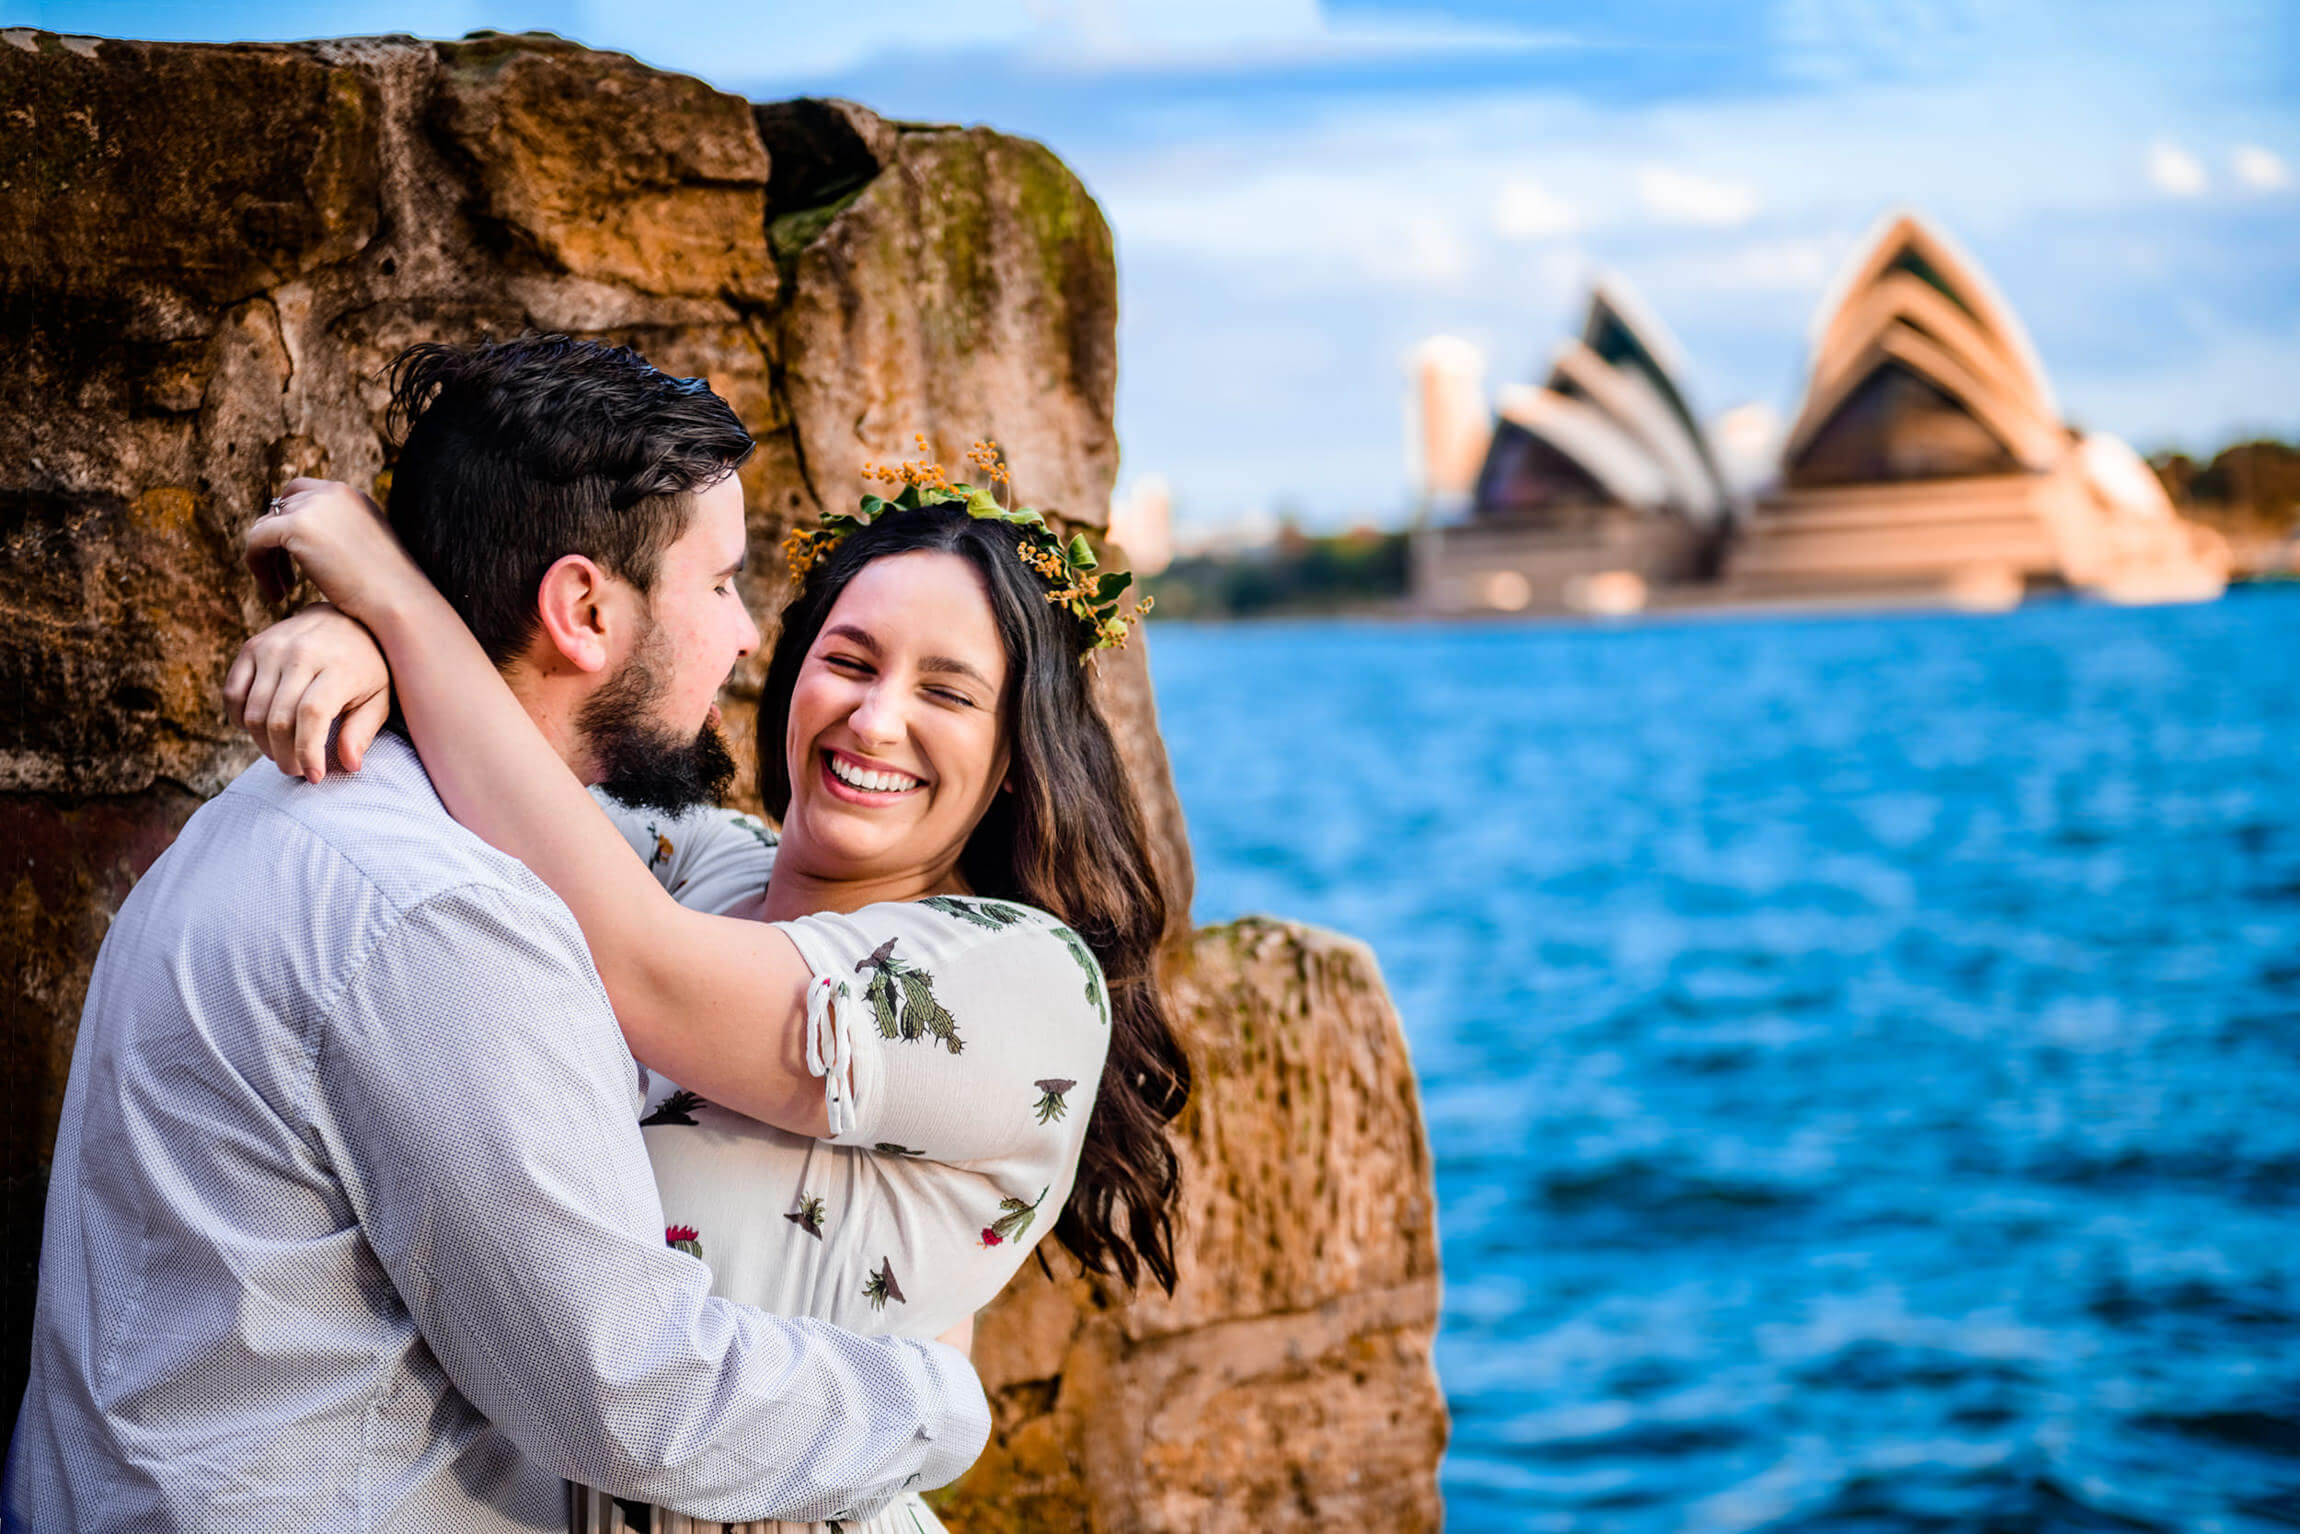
[1415,216,2229,612]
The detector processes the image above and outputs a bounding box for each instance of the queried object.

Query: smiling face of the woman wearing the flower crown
[782,550,1007,881]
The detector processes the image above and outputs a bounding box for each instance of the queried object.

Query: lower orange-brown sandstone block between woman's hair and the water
[943,920,1444,1534]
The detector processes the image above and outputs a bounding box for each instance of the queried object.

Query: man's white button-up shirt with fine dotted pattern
[0,736,989,1534]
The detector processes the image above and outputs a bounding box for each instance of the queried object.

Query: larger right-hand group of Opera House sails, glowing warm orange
[1727,214,2229,605]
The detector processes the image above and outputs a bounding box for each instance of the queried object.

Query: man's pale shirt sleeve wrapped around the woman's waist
[313,885,989,1523]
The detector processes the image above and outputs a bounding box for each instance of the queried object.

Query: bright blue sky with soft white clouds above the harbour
[22,0,2300,529]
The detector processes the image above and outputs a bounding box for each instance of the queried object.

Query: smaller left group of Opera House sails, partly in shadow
[1415,281,1734,612]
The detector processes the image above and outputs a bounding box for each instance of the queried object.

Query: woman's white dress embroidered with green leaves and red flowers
[573,796,1111,1534]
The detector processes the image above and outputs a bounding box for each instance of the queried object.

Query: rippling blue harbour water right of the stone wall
[1152,591,2300,1532]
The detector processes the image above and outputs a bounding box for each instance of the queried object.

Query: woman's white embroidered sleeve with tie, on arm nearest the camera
[777,895,1111,1207]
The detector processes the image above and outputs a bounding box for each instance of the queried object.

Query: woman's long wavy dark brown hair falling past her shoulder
[759,506,1189,1293]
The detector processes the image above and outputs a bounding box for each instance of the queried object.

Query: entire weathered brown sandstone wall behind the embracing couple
[0,28,1442,1527]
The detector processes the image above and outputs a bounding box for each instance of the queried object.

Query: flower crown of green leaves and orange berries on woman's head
[782,435,1155,658]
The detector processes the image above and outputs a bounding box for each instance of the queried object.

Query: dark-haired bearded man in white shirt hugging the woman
[0,336,989,1534]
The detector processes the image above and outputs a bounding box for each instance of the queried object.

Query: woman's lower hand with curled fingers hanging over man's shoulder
[223,603,391,782]
